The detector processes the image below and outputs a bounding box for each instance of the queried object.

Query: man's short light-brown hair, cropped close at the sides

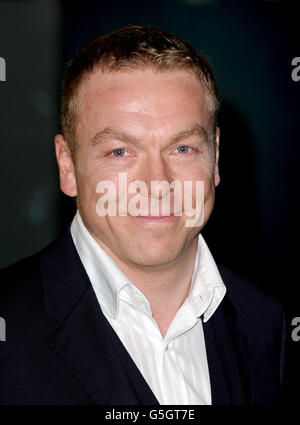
[61,25,219,156]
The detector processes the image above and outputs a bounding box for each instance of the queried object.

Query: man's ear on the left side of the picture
[54,134,77,197]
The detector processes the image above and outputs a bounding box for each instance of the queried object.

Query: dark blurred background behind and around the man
[0,0,300,397]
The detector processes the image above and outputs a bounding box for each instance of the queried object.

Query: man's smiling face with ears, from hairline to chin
[56,69,219,267]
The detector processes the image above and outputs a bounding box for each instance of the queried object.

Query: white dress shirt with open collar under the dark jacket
[71,211,226,405]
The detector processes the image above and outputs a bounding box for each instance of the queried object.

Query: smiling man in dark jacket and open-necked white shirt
[0,26,285,405]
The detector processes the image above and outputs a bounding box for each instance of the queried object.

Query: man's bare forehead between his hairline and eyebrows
[77,69,210,138]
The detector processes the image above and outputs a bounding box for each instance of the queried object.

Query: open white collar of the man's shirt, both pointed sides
[71,210,226,322]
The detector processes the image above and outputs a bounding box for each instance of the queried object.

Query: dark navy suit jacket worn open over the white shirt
[0,228,285,405]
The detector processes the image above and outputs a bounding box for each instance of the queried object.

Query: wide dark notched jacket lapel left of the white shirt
[40,231,158,405]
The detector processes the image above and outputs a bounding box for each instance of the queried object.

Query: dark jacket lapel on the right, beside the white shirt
[203,295,249,405]
